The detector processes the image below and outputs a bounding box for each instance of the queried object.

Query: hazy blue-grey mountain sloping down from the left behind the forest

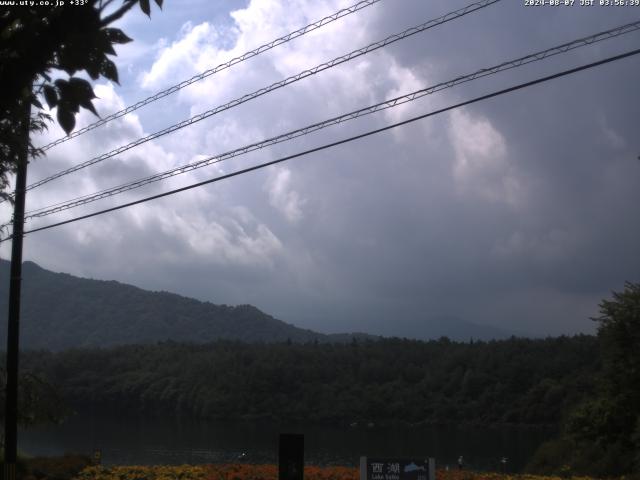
[0,260,377,351]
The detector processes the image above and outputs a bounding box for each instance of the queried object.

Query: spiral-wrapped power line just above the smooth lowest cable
[25,21,640,219]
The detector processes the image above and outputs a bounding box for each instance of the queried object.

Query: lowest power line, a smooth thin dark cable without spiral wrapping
[0,49,640,243]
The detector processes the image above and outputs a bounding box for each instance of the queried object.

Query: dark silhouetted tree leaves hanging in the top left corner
[0,0,162,198]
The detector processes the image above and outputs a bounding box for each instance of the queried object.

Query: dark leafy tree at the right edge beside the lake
[536,283,640,476]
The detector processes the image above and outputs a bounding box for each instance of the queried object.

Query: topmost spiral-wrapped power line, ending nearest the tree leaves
[40,0,380,151]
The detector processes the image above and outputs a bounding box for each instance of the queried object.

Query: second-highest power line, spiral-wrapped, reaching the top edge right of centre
[27,0,501,195]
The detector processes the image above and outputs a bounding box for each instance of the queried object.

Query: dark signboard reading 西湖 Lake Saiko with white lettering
[360,457,436,480]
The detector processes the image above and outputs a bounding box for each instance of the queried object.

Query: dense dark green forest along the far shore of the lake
[21,336,600,425]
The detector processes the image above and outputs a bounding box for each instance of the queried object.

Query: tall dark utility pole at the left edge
[2,92,31,480]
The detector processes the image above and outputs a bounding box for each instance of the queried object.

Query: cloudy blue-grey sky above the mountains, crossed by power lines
[0,0,640,337]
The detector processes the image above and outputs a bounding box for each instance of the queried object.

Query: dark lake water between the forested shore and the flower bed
[18,415,553,472]
